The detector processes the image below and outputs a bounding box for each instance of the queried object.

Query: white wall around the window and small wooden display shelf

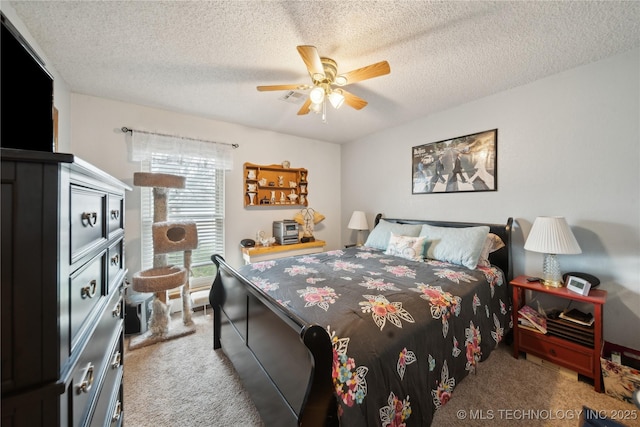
[70,94,341,274]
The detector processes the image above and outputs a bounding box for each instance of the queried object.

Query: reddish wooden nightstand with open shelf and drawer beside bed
[510,276,607,392]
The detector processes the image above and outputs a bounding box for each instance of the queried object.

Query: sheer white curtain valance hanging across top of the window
[131,130,233,170]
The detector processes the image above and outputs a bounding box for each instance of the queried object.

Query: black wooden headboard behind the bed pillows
[374,213,513,282]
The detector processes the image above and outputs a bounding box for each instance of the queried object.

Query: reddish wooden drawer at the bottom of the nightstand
[518,329,600,376]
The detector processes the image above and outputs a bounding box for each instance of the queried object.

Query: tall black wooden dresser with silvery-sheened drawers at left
[1,148,131,426]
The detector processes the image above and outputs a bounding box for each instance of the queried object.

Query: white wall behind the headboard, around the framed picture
[342,49,640,349]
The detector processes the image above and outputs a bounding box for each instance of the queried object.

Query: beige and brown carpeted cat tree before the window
[129,172,198,349]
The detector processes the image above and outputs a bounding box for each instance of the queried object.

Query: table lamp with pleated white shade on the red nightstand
[524,216,582,288]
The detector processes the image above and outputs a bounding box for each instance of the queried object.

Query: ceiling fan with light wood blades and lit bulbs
[257,45,391,122]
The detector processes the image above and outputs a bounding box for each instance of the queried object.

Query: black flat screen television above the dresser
[0,14,54,152]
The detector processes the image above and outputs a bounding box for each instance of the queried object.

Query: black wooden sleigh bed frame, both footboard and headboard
[209,214,513,426]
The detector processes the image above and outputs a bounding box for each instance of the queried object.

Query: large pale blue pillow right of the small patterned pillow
[420,224,489,270]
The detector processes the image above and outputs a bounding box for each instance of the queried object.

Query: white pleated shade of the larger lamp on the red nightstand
[524,216,582,254]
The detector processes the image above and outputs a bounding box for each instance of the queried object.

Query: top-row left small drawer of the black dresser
[70,185,107,264]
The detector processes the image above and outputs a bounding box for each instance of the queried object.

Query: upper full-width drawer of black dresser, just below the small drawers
[69,291,123,426]
